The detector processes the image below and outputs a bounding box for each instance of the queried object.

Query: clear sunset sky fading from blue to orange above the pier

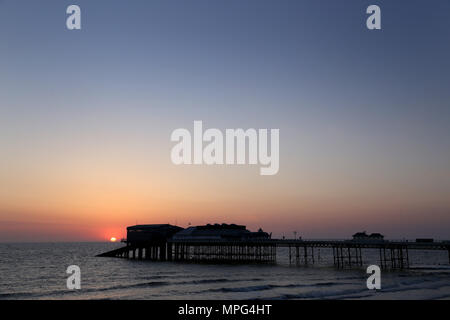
[0,0,450,242]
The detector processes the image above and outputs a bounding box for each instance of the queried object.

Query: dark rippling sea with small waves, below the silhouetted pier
[0,243,450,299]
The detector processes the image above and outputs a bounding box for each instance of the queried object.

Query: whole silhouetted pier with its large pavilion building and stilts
[98,225,450,269]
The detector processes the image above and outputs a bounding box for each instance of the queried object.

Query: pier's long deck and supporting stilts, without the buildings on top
[99,239,450,269]
